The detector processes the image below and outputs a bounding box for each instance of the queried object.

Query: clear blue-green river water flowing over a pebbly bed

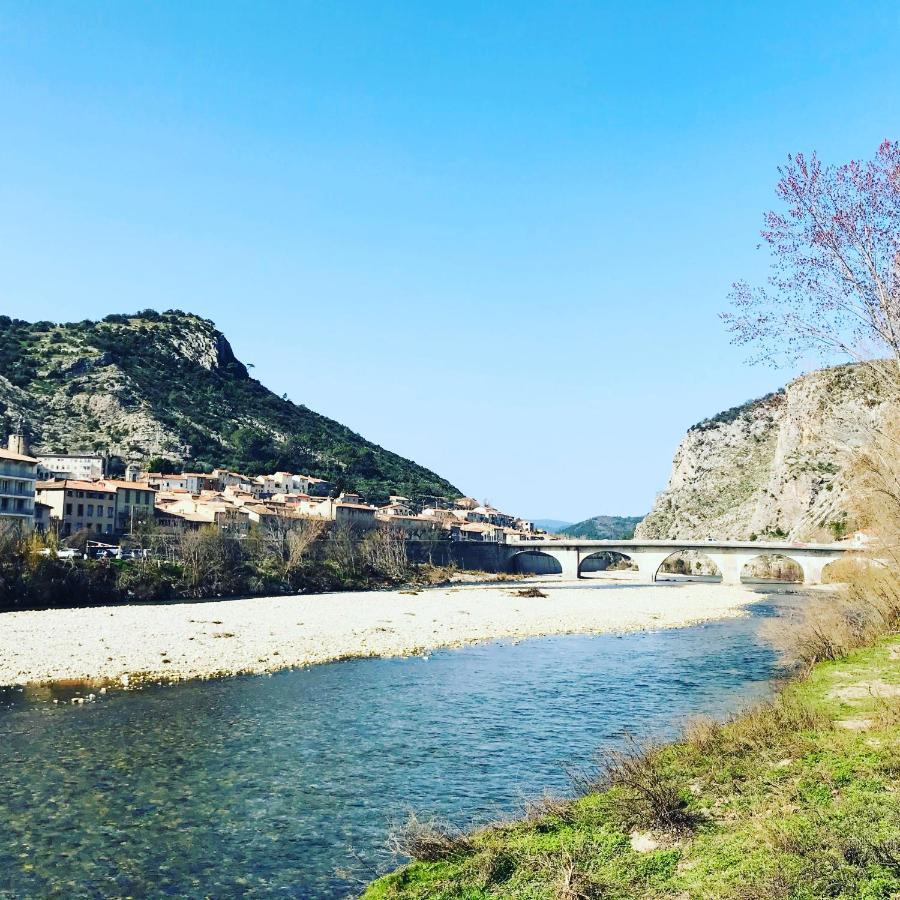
[0,588,790,898]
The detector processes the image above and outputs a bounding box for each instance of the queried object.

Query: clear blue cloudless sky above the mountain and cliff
[0,0,900,520]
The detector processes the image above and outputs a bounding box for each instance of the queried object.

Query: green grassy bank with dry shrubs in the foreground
[363,637,900,900]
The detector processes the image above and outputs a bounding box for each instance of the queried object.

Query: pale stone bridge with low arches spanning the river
[501,538,859,584]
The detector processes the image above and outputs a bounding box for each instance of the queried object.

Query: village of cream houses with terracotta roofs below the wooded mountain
[0,434,536,543]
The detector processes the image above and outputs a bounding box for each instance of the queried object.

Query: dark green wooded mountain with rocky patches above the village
[0,310,460,499]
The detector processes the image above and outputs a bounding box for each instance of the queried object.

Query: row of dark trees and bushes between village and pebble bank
[0,519,412,608]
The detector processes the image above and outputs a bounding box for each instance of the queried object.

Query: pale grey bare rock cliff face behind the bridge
[636,365,882,540]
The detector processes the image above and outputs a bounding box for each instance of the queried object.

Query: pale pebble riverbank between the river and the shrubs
[0,576,758,685]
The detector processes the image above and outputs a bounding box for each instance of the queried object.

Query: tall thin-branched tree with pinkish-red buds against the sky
[722,140,900,378]
